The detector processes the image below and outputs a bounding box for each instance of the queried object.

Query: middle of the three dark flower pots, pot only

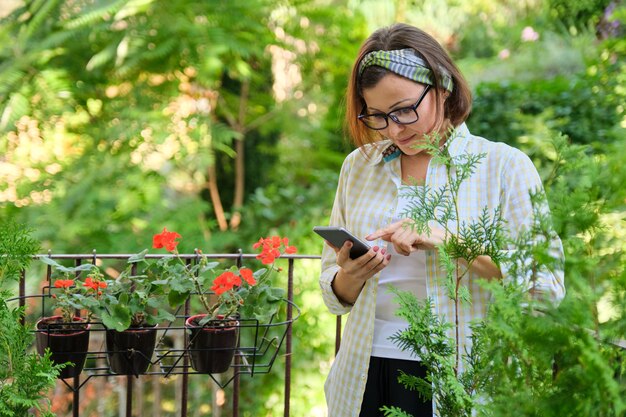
[105,326,157,376]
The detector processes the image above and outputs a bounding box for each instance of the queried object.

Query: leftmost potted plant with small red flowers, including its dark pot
[35,257,107,379]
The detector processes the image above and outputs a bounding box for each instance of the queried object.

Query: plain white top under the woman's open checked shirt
[371,186,427,360]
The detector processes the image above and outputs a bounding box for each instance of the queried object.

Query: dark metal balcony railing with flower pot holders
[13,250,322,417]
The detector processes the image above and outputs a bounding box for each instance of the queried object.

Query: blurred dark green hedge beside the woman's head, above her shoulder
[468,70,625,148]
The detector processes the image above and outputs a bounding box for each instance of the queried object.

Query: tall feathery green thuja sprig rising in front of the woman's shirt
[398,128,506,402]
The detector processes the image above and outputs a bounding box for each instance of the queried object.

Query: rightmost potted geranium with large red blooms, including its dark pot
[153,229,297,374]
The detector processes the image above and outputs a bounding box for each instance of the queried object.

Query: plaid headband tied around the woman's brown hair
[359,48,454,92]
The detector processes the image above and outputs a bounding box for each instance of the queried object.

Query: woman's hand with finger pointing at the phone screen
[365,219,444,256]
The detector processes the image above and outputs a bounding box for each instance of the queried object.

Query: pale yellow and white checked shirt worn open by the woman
[320,124,565,417]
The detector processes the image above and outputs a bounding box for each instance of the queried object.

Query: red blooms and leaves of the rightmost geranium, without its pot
[153,229,297,325]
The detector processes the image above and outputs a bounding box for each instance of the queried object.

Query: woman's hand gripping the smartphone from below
[326,241,391,304]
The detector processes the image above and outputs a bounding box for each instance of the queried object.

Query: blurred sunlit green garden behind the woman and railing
[0,0,626,416]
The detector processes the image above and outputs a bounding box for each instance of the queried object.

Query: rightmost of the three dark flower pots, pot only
[185,314,239,374]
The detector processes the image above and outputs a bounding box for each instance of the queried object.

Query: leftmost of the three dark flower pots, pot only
[35,316,91,379]
